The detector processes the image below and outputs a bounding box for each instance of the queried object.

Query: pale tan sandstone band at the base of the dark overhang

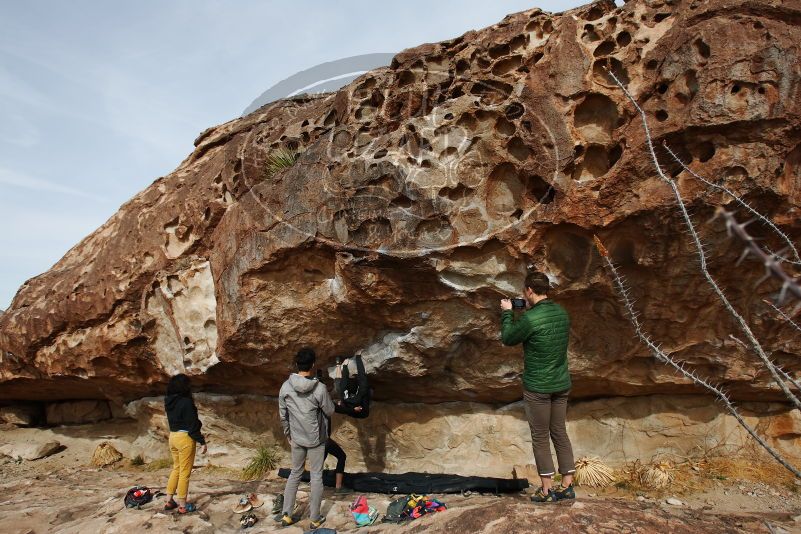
[126,394,801,478]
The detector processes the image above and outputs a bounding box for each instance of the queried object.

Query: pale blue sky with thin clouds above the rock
[0,0,586,309]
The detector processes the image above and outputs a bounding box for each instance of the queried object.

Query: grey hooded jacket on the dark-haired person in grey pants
[278,373,334,447]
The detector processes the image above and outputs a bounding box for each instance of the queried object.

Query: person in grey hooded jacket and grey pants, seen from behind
[278,348,334,530]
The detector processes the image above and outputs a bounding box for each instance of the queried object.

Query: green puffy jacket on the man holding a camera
[501,299,571,393]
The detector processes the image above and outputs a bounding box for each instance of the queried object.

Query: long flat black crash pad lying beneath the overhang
[278,468,529,494]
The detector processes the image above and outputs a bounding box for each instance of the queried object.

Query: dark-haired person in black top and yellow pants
[164,374,207,514]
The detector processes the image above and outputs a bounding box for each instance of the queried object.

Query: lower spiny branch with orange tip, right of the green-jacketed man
[595,236,801,478]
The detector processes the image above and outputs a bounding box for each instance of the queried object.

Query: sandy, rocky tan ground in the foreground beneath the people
[0,423,801,534]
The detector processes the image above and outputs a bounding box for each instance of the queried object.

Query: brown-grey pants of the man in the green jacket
[523,390,576,476]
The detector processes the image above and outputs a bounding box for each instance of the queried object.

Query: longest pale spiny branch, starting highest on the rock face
[607,70,801,410]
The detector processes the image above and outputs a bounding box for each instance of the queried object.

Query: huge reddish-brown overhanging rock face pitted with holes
[0,0,801,452]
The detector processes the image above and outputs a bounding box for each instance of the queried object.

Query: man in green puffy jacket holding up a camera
[501,271,576,502]
